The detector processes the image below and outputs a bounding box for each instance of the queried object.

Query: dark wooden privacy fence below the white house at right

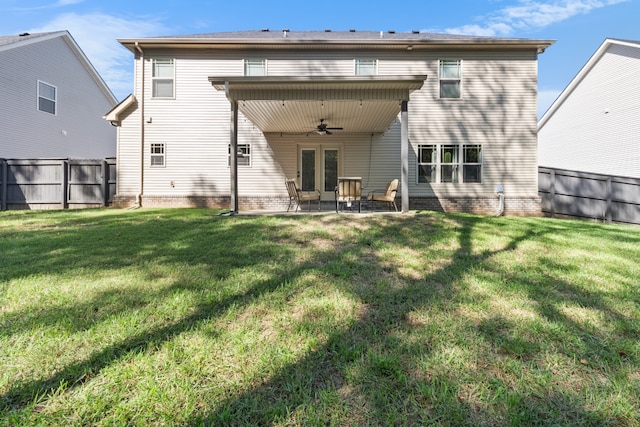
[538,167,640,224]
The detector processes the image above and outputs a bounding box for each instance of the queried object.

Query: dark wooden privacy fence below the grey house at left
[0,158,116,210]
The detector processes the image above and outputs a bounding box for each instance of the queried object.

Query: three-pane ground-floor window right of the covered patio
[418,144,482,183]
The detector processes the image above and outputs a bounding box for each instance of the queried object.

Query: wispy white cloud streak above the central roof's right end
[444,0,629,37]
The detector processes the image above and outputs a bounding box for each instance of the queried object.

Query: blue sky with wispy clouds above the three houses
[0,0,640,115]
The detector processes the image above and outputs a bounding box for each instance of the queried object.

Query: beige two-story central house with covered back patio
[105,30,553,215]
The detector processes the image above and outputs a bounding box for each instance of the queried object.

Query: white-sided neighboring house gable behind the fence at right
[538,38,640,178]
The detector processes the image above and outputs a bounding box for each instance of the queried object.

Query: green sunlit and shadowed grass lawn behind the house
[0,209,640,426]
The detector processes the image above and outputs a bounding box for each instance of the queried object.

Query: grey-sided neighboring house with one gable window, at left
[0,31,117,159]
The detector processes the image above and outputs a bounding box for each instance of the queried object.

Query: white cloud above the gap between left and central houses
[29,12,165,100]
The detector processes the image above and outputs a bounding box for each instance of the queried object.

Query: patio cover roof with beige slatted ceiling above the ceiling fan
[209,75,427,134]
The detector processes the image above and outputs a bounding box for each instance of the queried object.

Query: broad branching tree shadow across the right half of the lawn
[189,217,637,425]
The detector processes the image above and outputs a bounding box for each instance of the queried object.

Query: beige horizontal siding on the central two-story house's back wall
[119,46,538,208]
